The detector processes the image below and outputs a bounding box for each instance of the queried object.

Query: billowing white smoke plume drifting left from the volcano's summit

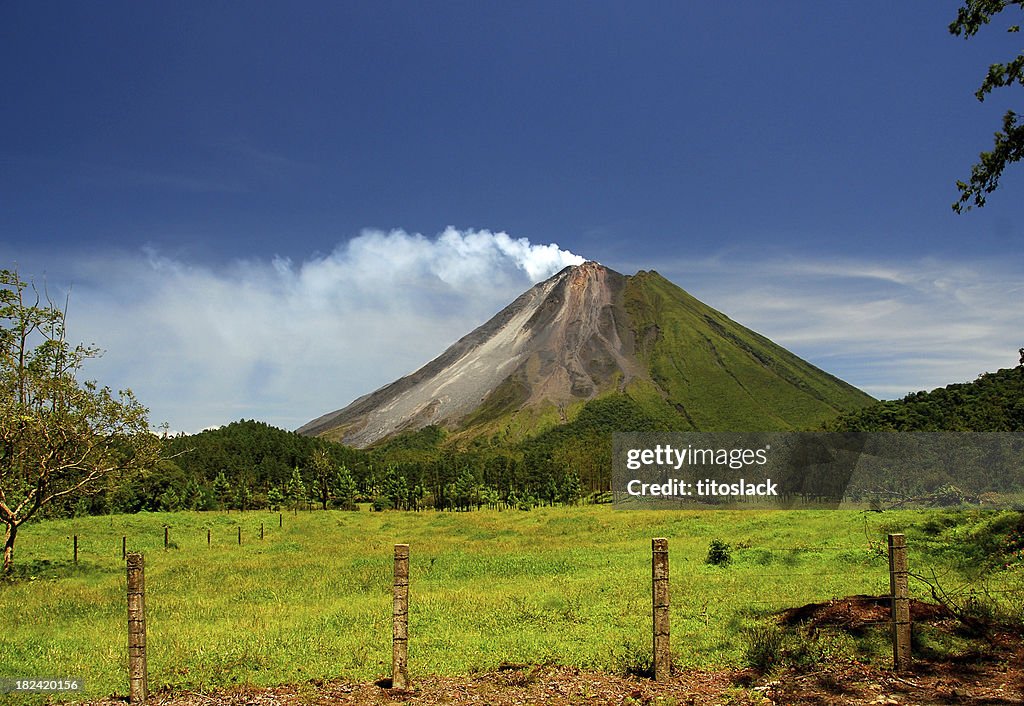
[34,227,584,432]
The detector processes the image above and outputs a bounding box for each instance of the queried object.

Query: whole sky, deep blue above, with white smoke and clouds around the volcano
[0,1,1024,431]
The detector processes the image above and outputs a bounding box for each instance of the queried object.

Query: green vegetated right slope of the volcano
[456,272,873,440]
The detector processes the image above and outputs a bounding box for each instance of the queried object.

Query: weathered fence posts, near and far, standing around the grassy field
[116,524,911,703]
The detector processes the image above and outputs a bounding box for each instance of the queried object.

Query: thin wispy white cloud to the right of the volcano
[647,257,1024,399]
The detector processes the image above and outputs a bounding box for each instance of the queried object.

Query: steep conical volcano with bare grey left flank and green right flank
[298,261,873,448]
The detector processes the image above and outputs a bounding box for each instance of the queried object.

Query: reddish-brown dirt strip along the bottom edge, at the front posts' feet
[68,653,1024,706]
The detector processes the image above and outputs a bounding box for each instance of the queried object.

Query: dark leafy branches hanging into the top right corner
[949,0,1024,213]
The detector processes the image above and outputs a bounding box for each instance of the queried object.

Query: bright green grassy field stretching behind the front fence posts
[0,506,1007,697]
